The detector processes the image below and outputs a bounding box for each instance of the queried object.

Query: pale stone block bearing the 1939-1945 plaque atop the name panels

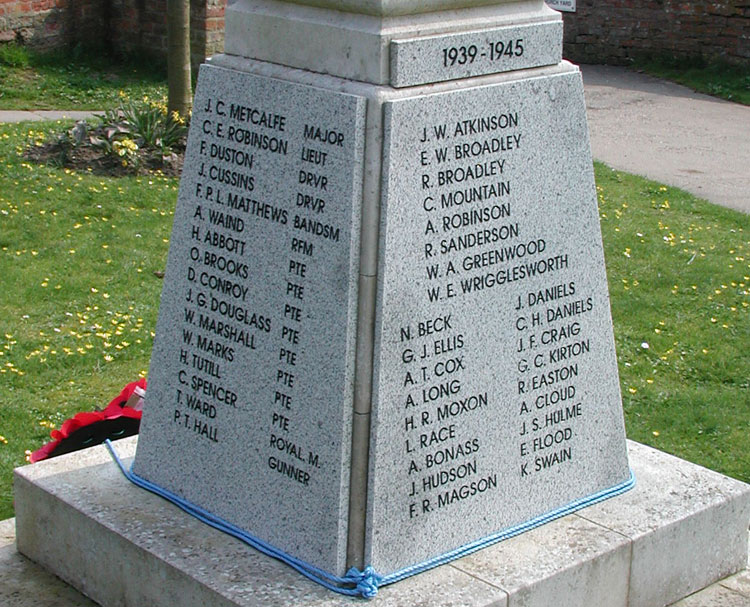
[224,0,562,88]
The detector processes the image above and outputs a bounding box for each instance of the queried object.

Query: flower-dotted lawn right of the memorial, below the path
[596,165,750,482]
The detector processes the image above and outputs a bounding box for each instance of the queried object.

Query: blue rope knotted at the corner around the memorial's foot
[105,440,635,598]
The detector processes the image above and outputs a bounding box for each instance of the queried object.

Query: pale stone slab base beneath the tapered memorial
[15,437,750,607]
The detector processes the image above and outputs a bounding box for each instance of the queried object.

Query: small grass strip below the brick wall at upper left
[0,44,167,110]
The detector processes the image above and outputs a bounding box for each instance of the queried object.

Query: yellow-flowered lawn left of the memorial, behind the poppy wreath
[0,123,178,520]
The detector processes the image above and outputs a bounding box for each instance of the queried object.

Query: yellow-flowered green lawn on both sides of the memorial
[0,123,750,519]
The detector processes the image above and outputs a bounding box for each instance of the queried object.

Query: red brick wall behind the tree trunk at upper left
[0,0,227,64]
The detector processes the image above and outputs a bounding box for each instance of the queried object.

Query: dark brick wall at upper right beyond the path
[563,0,750,65]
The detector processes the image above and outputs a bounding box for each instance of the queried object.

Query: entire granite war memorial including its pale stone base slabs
[11,0,750,605]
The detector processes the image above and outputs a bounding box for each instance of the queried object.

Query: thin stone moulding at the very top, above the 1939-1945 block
[280,0,524,17]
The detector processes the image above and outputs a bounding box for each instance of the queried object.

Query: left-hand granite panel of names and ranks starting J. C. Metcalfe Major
[134,65,364,573]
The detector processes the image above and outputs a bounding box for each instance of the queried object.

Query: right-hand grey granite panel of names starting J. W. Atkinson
[366,72,629,573]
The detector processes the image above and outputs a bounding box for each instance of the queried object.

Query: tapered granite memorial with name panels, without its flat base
[133,0,633,587]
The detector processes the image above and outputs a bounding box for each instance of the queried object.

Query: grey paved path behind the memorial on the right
[581,65,750,213]
